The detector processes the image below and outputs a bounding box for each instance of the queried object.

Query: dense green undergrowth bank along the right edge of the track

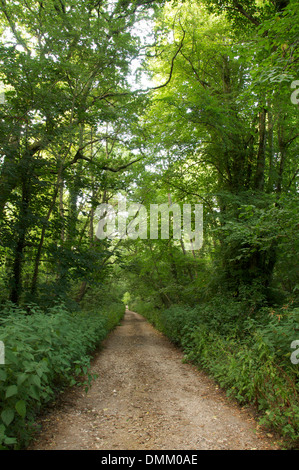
[139,298,299,446]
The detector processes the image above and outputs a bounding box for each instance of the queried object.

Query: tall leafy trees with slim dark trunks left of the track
[0,0,162,303]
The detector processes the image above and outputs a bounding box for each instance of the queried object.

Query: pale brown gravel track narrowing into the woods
[29,311,280,450]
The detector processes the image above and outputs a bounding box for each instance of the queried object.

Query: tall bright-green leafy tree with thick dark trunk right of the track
[138,0,298,302]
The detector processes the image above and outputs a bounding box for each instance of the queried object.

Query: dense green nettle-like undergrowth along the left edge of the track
[0,304,124,448]
